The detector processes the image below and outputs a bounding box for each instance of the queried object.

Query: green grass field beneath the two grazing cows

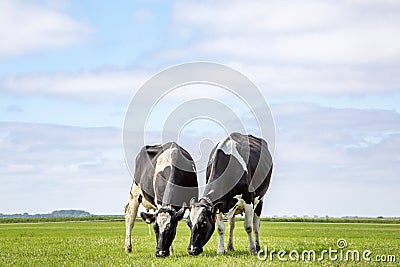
[0,221,400,266]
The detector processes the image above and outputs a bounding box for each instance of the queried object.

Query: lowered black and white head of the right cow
[187,198,217,256]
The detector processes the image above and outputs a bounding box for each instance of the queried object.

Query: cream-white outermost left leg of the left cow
[124,184,140,252]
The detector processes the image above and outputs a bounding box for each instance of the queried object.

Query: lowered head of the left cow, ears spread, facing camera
[140,206,186,257]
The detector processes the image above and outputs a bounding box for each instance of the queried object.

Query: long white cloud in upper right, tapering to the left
[194,23,400,64]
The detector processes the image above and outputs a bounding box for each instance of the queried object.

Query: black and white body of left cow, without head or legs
[134,142,198,209]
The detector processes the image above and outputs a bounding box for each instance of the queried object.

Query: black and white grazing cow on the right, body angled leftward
[187,133,272,255]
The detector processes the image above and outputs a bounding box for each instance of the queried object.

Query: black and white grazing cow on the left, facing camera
[125,142,198,257]
